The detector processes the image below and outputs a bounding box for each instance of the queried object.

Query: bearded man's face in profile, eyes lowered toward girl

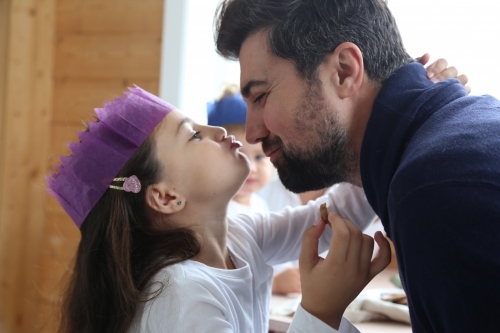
[240,32,356,193]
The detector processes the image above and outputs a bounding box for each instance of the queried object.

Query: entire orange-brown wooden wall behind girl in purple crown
[0,0,164,333]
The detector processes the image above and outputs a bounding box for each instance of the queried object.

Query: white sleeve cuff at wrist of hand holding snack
[287,305,359,333]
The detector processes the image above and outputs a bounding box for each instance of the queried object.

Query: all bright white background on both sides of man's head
[160,0,500,123]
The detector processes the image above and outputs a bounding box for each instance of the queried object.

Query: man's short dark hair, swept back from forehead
[215,0,413,83]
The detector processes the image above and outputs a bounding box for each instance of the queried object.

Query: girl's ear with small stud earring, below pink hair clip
[146,183,185,214]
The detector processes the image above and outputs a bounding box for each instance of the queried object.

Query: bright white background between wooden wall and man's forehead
[160,0,240,124]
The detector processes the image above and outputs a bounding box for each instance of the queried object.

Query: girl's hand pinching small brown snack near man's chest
[299,213,391,329]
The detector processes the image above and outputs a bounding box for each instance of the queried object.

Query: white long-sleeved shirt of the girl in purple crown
[129,185,369,333]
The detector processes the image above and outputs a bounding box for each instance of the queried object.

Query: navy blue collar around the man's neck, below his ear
[360,62,466,228]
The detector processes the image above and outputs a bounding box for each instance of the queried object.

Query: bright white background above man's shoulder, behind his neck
[389,0,500,98]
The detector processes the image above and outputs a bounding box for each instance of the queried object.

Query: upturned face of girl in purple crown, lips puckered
[153,110,250,204]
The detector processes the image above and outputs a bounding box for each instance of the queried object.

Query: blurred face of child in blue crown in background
[231,127,274,200]
